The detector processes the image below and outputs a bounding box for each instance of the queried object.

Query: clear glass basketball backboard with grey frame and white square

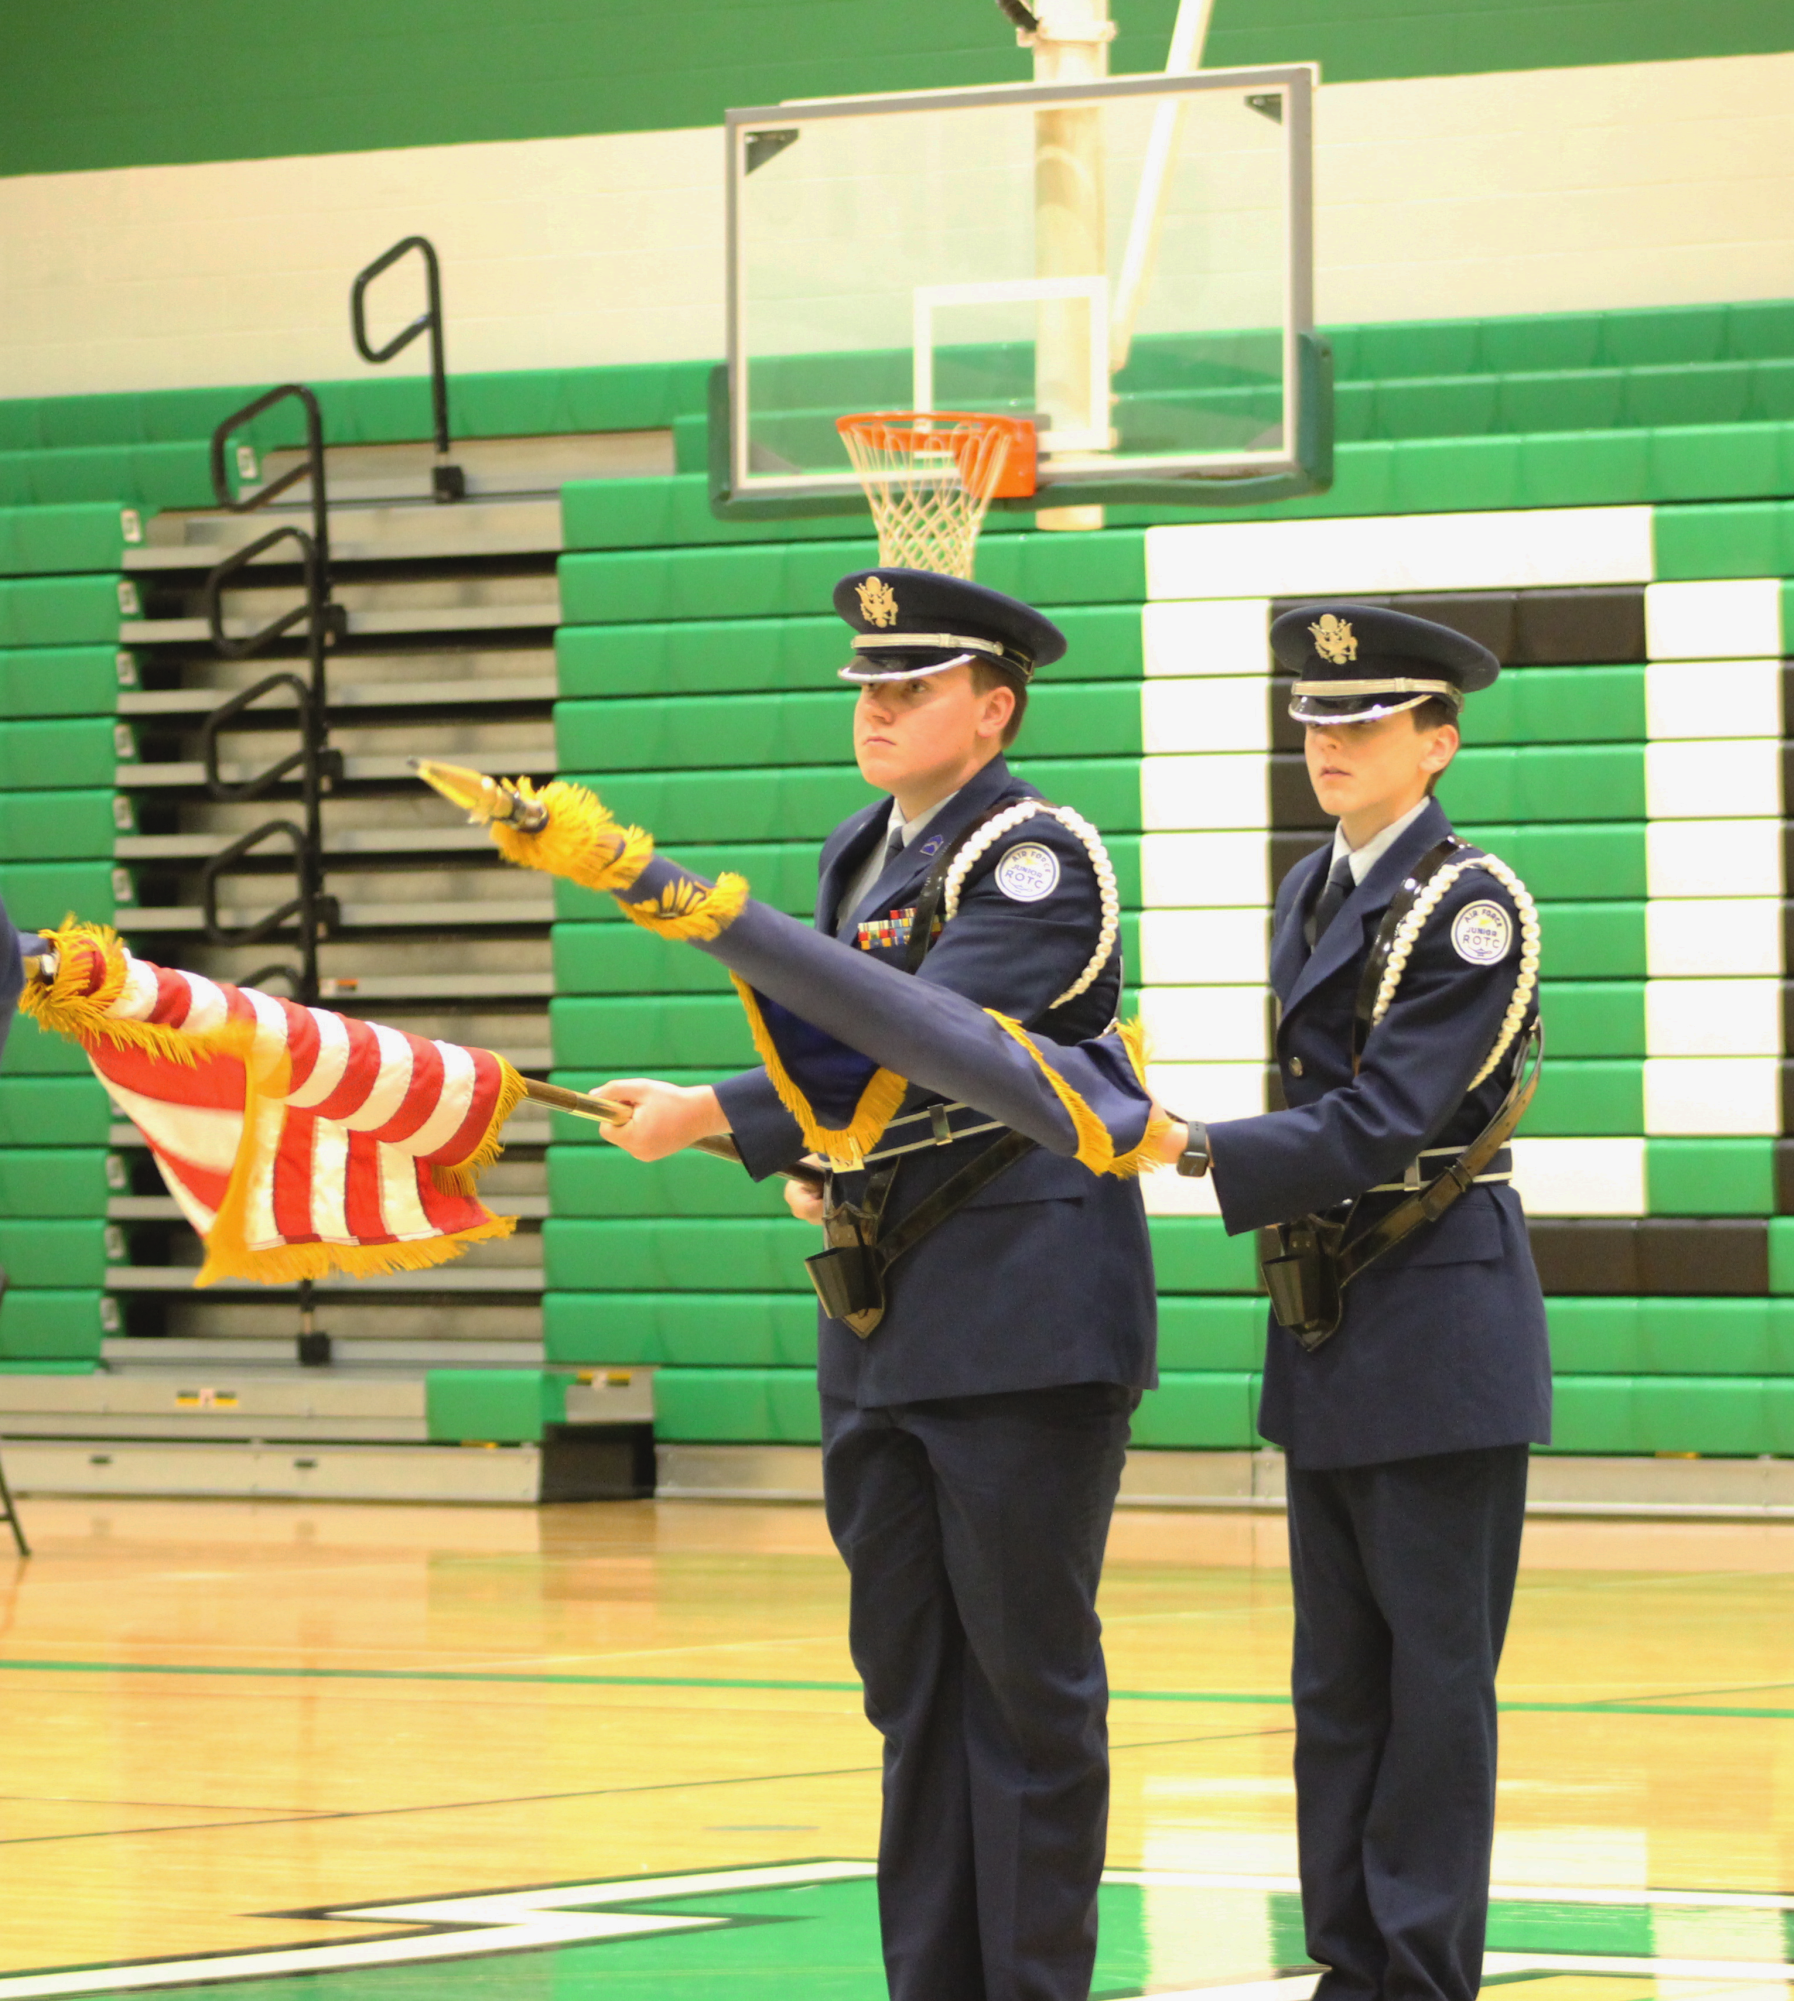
[712,64,1332,514]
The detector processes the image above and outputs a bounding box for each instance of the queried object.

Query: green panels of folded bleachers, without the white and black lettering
[17,300,1794,1453]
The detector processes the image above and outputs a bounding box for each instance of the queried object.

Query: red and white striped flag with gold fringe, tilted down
[20,922,524,1285]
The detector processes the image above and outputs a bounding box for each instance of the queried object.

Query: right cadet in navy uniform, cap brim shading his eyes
[1152,604,1550,2001]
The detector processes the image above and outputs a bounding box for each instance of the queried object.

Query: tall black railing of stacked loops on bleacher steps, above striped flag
[200,382,346,1007]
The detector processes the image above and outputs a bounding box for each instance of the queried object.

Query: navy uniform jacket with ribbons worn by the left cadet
[716,758,1158,1405]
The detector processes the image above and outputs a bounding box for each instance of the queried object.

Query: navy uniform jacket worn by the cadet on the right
[1208,804,1550,1469]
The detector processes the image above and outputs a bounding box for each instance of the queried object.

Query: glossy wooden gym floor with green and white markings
[0,1501,1794,2001]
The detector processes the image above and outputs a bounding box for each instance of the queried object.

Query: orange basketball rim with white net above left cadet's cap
[834,410,1036,576]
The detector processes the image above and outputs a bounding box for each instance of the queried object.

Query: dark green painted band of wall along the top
[0,0,1794,174]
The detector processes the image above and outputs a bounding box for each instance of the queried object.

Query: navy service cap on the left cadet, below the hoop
[834,568,1066,684]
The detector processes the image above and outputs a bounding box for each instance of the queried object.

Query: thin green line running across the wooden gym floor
[0,1661,1794,1723]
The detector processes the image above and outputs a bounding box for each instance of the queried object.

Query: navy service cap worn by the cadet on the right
[1270,602,1502,722]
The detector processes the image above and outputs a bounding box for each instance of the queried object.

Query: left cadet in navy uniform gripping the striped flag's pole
[604,568,1156,2001]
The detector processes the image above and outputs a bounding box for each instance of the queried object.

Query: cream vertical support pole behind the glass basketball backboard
[1020,0,1116,530]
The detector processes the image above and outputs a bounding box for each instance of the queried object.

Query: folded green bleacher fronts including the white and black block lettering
[0,302,1794,1488]
